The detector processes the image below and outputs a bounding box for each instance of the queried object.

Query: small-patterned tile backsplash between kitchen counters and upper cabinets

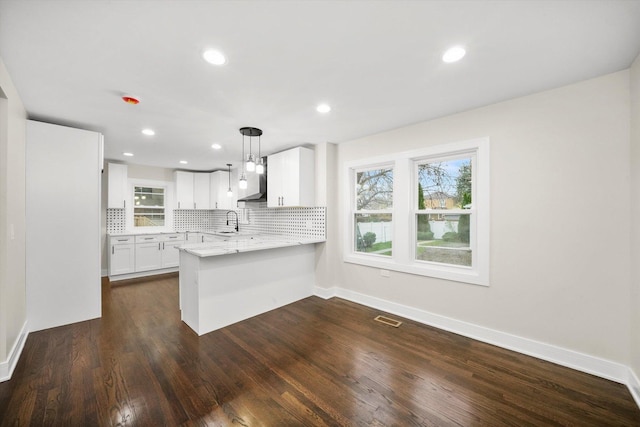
[107,205,326,239]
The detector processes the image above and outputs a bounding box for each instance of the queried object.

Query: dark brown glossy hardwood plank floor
[0,276,640,426]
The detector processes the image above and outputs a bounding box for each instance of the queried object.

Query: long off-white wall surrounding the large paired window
[318,71,631,365]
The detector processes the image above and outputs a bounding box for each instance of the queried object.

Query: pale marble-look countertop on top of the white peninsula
[178,234,325,258]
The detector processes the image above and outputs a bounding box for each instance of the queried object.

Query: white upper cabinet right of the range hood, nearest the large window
[267,147,315,208]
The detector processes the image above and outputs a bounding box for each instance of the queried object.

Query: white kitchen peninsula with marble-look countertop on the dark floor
[180,235,323,335]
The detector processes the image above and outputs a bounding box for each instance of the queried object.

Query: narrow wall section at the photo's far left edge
[0,59,27,380]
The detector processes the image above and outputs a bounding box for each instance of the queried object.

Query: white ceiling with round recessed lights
[0,0,640,170]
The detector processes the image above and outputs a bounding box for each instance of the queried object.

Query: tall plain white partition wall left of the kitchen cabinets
[26,120,102,331]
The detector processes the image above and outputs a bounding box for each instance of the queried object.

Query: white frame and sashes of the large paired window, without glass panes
[342,137,490,286]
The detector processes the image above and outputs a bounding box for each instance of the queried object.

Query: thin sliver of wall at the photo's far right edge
[630,56,640,394]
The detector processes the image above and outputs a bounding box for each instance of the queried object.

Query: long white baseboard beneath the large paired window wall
[315,287,640,392]
